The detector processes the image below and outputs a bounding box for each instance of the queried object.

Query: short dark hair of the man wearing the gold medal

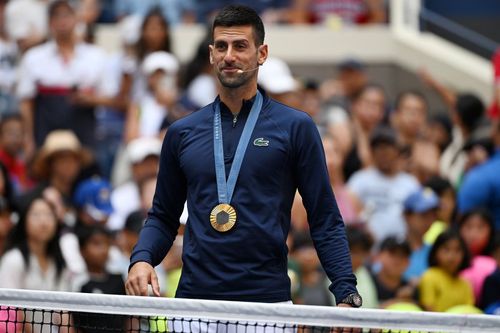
[212,5,265,46]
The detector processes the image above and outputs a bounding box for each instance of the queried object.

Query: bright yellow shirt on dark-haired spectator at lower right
[419,267,474,312]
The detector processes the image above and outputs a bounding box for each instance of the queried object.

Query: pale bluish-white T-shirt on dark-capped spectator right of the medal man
[347,168,419,242]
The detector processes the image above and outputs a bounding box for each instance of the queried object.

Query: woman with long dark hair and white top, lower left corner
[0,196,70,291]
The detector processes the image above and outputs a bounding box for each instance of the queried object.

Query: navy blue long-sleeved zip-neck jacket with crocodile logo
[131,91,356,302]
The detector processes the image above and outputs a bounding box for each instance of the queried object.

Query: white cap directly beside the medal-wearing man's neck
[257,57,297,94]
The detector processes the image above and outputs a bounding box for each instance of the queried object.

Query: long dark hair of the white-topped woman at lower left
[6,195,66,278]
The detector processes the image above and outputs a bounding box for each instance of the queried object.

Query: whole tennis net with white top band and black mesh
[0,289,500,333]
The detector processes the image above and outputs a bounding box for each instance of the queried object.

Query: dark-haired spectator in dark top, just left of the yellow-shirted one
[372,236,414,308]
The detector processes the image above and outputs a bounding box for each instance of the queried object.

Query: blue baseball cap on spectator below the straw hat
[74,177,113,221]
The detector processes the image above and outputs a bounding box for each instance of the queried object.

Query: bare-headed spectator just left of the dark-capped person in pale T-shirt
[344,84,385,180]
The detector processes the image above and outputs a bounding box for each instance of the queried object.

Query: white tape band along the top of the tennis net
[0,289,500,333]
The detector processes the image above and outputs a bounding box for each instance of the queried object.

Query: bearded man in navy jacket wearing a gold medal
[126,6,361,307]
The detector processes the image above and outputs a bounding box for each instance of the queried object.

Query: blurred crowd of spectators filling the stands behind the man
[0,0,500,320]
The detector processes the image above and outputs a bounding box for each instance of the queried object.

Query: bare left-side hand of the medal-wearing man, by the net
[125,261,160,297]
